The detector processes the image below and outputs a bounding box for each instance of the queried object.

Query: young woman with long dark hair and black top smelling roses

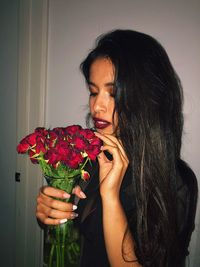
[36,30,197,267]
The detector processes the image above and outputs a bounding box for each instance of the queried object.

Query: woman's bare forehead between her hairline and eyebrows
[89,58,114,82]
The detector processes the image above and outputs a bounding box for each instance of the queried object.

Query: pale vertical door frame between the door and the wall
[15,0,49,267]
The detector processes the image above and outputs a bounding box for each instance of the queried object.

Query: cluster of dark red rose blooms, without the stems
[17,125,102,176]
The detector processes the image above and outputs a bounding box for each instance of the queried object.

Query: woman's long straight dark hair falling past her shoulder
[81,30,183,267]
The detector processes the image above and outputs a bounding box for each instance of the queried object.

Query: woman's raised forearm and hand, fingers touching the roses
[96,133,141,267]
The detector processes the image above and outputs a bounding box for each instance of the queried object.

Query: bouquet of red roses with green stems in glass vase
[17,125,101,267]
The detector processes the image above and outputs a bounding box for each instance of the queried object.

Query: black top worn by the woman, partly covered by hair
[77,161,197,267]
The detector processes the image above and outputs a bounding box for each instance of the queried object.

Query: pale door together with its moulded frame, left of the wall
[0,0,48,267]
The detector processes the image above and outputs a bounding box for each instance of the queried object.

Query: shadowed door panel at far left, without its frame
[0,0,19,267]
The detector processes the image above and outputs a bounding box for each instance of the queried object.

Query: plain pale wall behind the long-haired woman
[46,0,200,267]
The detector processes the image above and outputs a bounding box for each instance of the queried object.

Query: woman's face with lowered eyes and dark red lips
[88,58,117,134]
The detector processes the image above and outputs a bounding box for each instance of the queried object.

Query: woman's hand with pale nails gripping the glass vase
[36,186,86,225]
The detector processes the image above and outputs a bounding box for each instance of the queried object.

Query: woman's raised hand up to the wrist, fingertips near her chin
[95,133,129,199]
